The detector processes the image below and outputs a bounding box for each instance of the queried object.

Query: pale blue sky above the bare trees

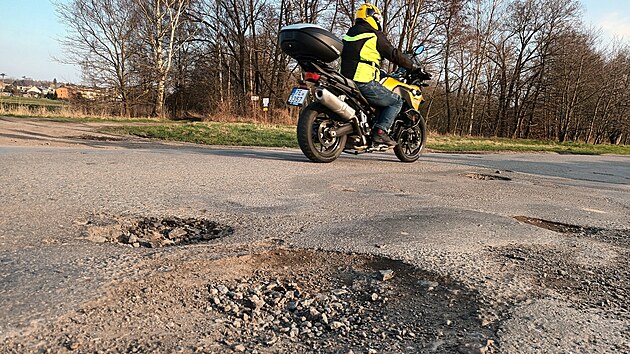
[0,0,630,83]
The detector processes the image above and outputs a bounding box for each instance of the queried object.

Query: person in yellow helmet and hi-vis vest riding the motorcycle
[341,4,421,147]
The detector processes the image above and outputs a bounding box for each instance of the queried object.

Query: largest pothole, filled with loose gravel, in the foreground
[0,248,496,353]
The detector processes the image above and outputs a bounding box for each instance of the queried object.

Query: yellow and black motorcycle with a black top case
[279,24,430,163]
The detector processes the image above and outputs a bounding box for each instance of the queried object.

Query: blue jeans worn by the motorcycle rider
[357,81,403,131]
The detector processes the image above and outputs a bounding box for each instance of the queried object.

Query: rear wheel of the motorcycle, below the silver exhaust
[297,102,348,163]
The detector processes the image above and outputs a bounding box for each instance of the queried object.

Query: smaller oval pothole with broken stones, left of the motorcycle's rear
[84,216,234,248]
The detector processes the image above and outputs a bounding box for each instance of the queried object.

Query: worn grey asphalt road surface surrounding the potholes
[0,129,630,353]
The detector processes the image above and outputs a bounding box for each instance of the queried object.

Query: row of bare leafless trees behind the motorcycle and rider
[58,0,630,144]
